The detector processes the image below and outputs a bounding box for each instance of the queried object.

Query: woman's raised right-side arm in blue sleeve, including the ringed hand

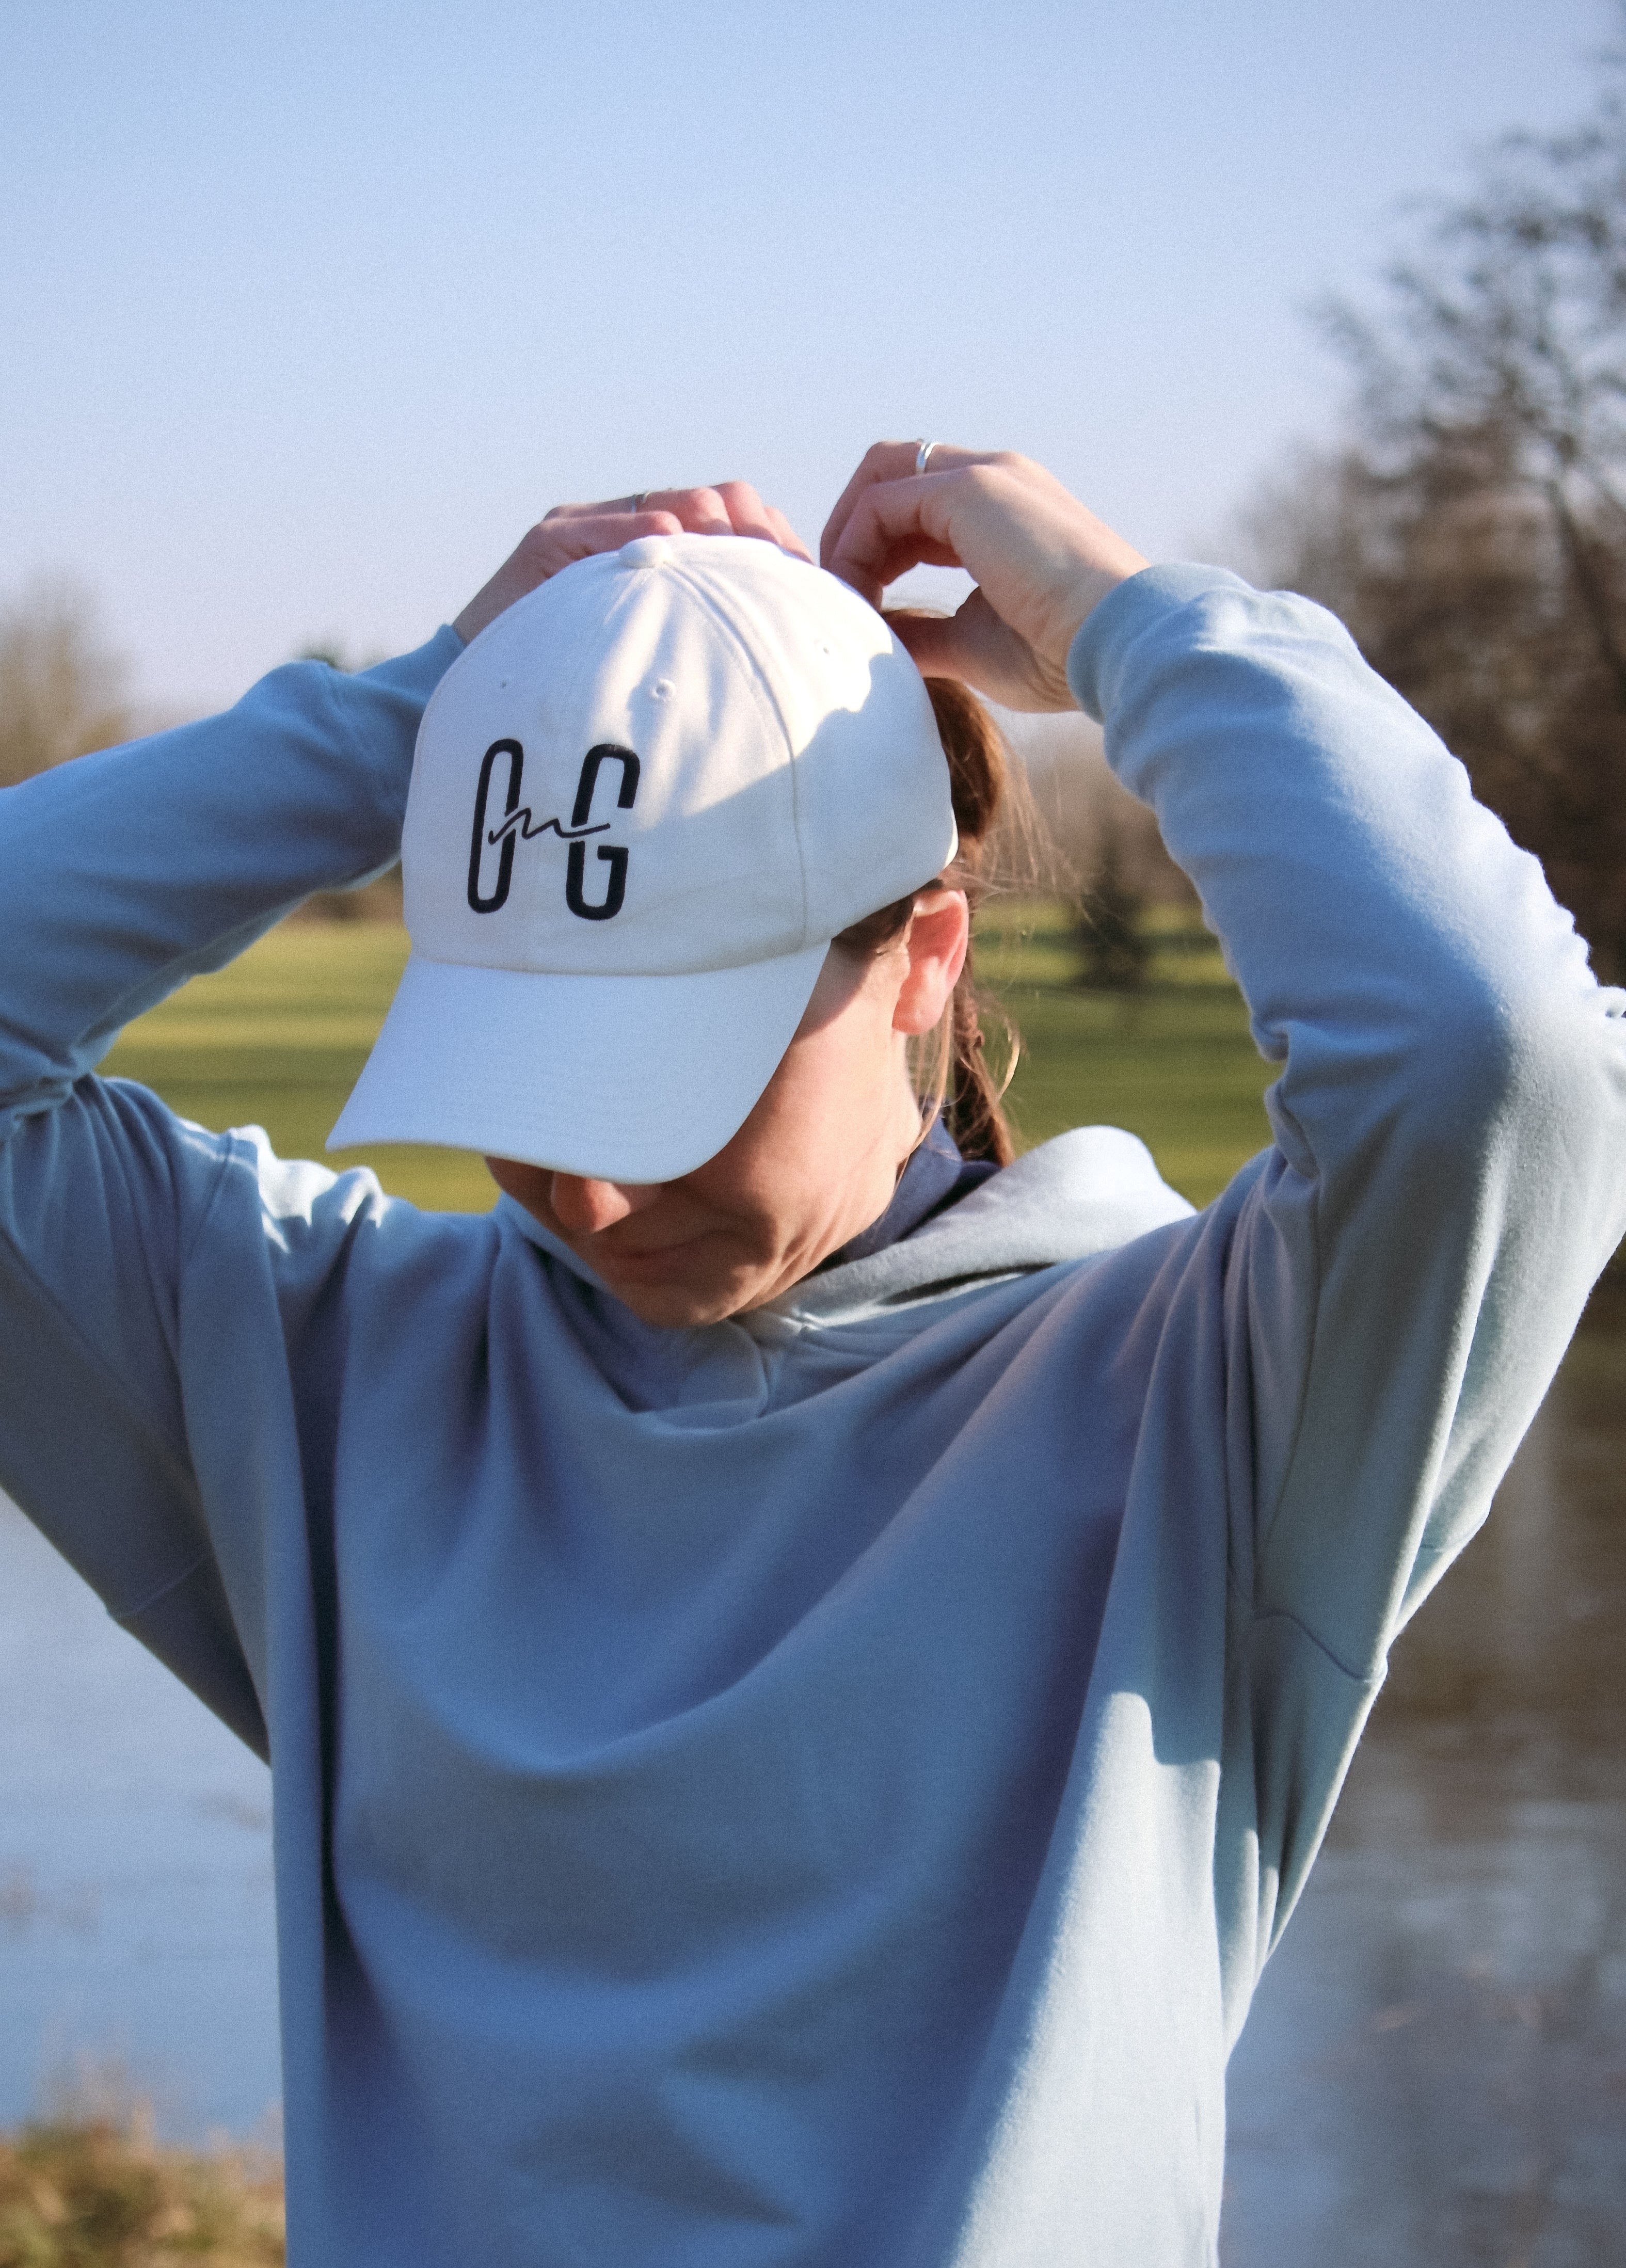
[825,444,1626,2005]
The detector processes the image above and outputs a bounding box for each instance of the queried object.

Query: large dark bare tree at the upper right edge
[1252,7,1626,978]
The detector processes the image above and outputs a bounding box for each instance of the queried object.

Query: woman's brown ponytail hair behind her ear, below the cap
[835,678,1018,1166]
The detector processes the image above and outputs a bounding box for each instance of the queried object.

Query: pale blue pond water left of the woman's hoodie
[0,1497,281,2139]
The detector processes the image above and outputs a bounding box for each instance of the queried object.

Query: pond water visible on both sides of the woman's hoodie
[0,1329,1626,2268]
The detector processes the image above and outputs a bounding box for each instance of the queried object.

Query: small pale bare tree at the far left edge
[0,581,134,787]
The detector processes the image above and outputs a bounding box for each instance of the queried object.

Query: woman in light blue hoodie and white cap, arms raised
[0,444,1626,2268]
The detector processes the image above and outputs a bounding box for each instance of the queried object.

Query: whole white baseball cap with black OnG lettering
[327,535,955,1181]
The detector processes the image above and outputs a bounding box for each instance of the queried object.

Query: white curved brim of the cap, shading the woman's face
[327,944,828,1181]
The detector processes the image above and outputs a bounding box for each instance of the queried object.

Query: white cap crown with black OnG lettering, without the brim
[402,535,955,975]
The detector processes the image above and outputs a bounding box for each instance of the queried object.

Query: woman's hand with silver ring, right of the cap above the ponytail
[819,440,1147,710]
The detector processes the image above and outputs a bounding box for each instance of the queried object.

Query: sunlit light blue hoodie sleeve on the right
[1071,567,1626,1681]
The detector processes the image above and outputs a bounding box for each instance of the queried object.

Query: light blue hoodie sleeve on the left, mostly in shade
[0,631,460,1739]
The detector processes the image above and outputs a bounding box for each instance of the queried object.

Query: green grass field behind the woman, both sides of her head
[104,903,1270,1211]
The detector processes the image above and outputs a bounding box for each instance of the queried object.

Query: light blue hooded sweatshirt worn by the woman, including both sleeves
[0,569,1626,2268]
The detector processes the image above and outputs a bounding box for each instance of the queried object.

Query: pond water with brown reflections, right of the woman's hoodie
[1222,1329,1626,2268]
